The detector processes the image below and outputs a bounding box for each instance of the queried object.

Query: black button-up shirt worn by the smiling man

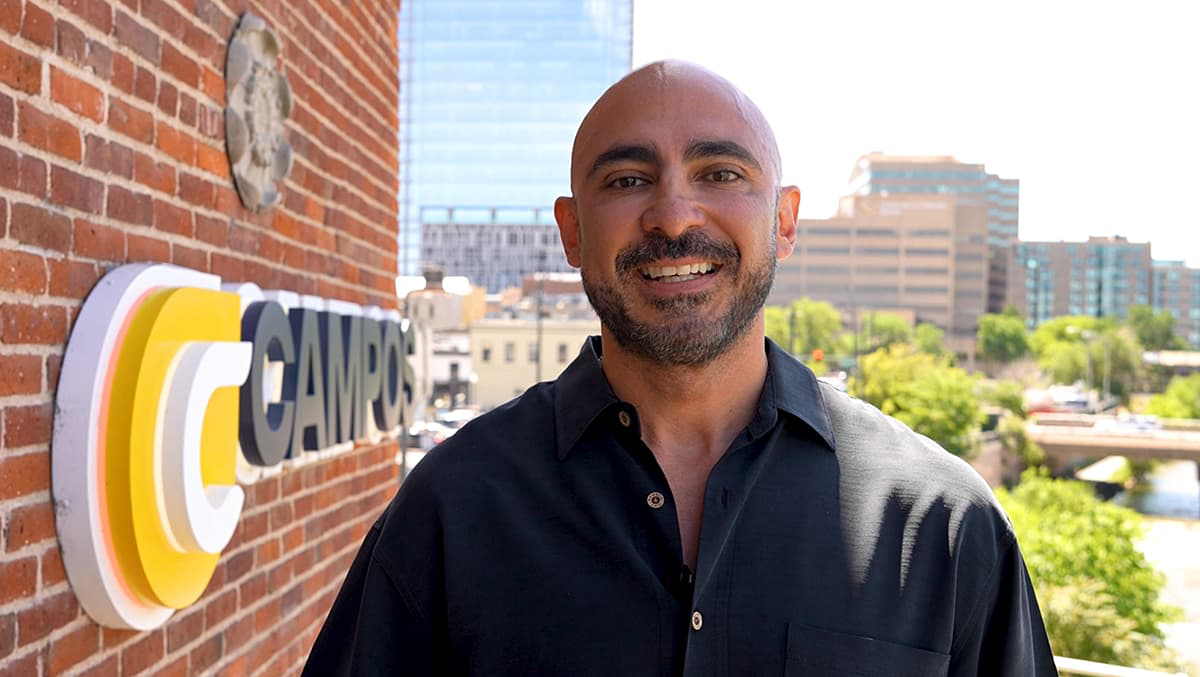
[305,337,1057,677]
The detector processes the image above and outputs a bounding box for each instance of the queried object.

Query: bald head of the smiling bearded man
[554,61,799,365]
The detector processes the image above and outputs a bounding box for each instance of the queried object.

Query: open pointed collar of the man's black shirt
[554,336,836,460]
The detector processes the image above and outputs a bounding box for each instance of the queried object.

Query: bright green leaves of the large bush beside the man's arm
[996,471,1178,648]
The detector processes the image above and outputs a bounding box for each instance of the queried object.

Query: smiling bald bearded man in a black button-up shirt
[306,61,1056,677]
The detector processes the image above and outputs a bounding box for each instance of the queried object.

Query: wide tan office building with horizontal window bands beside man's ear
[768,192,988,354]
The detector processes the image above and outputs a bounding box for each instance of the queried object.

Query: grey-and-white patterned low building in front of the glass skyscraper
[421,208,574,292]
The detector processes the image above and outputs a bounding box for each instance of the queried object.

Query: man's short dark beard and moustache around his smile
[582,227,776,366]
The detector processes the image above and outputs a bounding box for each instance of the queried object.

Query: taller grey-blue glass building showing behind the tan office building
[850,152,1021,312]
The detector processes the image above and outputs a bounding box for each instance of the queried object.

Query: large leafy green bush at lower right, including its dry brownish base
[996,471,1178,670]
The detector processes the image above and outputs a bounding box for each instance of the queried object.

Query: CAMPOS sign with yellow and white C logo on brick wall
[50,264,412,630]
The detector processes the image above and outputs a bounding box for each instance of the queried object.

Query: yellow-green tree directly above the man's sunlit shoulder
[850,343,983,456]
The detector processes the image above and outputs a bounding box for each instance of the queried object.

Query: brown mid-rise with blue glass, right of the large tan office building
[1008,235,1153,329]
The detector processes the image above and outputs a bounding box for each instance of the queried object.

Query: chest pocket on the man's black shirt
[784,623,950,677]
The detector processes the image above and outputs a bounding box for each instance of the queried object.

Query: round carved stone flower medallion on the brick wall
[226,12,292,211]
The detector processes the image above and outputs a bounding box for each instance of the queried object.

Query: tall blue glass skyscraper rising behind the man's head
[398,0,632,275]
